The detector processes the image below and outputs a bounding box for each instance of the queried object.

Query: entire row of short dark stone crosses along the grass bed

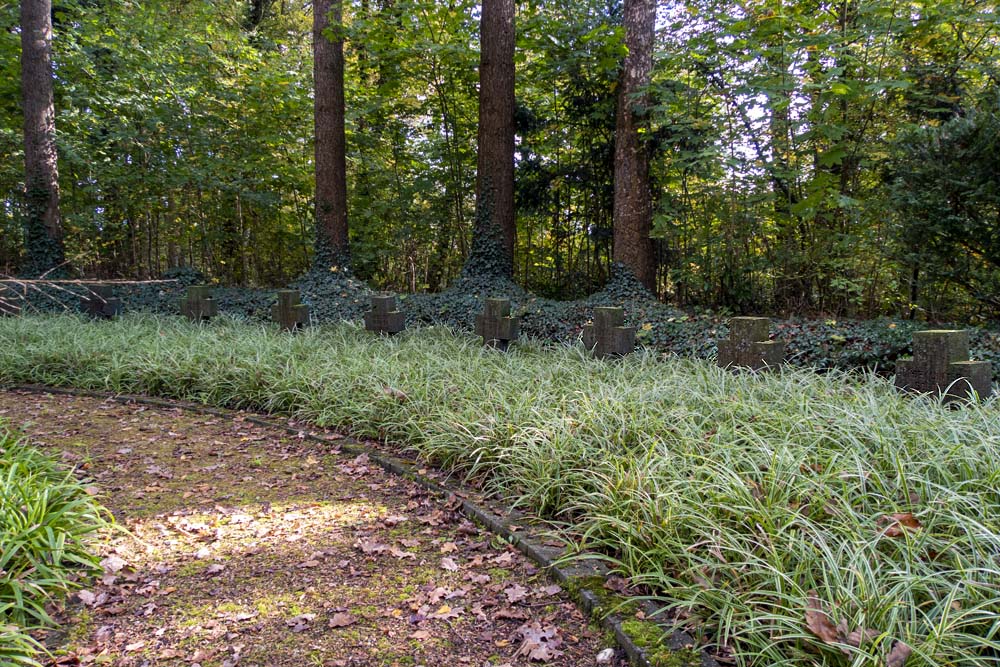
[0,285,993,399]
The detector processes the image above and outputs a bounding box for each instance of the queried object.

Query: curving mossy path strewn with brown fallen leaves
[0,391,624,667]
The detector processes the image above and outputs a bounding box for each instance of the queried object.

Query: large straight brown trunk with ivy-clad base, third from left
[465,0,516,278]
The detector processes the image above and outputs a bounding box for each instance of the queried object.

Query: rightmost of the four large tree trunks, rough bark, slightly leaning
[613,0,656,289]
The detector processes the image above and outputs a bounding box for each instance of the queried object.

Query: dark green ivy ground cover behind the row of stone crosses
[9,270,1000,381]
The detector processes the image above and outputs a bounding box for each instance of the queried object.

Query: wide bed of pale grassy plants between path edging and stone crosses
[0,316,1000,667]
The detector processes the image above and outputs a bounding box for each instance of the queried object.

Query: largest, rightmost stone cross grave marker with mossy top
[896,329,993,399]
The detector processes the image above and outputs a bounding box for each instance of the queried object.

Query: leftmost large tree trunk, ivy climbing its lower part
[21,0,65,275]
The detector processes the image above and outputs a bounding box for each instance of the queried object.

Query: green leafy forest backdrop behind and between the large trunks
[0,0,1000,322]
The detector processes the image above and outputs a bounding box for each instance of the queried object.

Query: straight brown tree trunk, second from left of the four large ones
[313,0,350,269]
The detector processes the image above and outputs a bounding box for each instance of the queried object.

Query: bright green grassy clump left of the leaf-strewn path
[0,422,109,665]
